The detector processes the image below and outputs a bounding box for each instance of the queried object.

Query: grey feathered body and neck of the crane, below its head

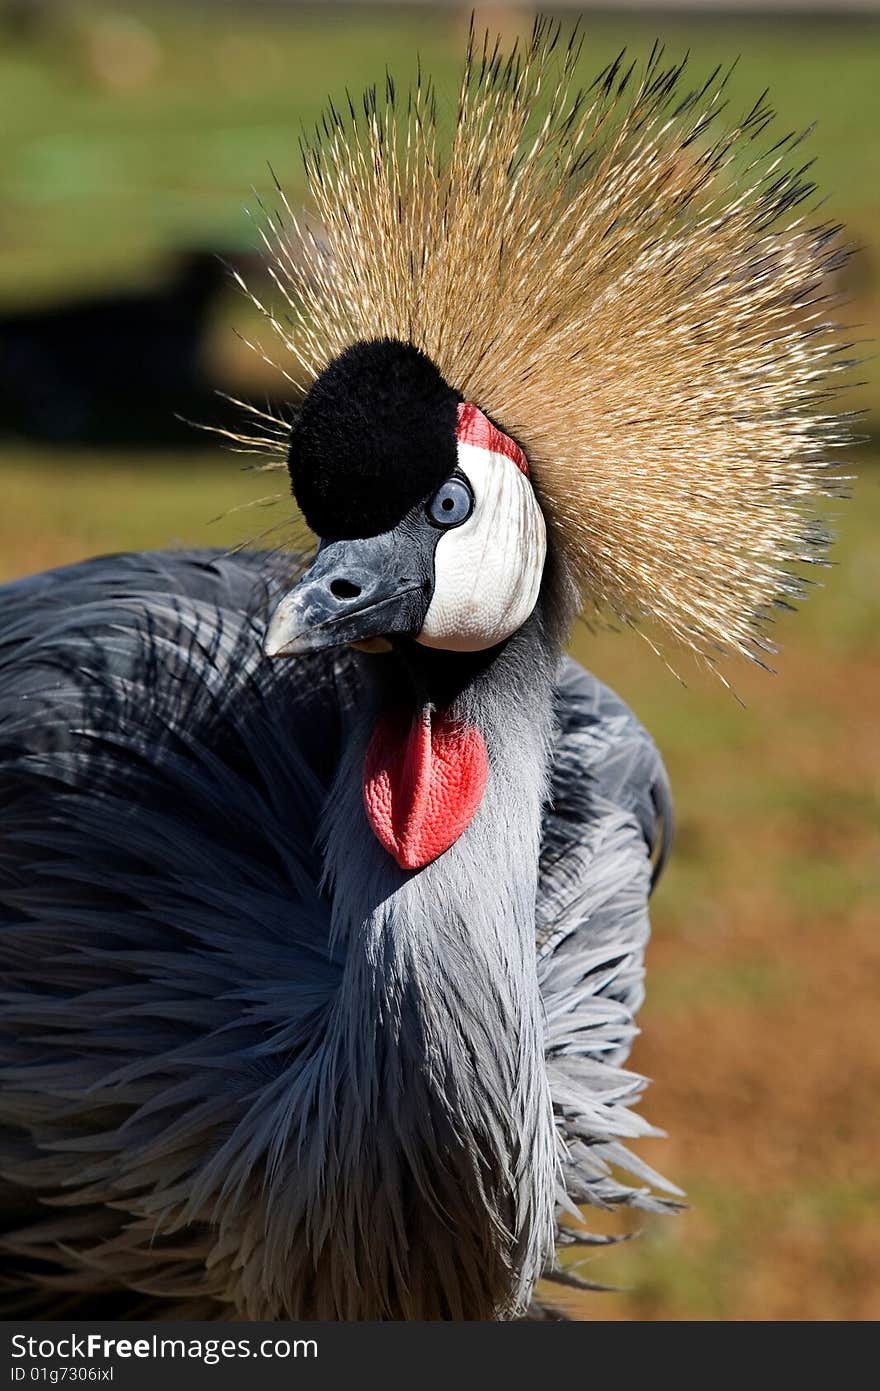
[0,552,669,1319]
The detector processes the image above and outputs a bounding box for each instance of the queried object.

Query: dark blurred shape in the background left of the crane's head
[0,252,257,448]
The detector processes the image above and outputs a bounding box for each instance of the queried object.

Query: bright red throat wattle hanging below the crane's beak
[363,707,488,869]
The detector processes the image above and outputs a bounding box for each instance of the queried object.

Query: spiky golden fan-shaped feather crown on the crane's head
[227,19,848,662]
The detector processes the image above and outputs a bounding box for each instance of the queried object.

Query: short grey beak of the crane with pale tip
[263,531,430,657]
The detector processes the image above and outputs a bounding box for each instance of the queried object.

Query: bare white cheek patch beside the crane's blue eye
[417,440,546,652]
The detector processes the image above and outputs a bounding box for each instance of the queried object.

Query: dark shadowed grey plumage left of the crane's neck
[0,554,343,1316]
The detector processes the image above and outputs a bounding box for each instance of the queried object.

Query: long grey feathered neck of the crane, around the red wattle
[309,600,559,1319]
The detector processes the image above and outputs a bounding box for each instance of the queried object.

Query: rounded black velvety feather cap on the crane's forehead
[288,338,462,540]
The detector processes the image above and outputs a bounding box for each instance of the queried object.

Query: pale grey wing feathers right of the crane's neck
[535,645,677,1235]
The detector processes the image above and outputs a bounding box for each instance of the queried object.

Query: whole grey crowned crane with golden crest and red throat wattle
[0,22,838,1319]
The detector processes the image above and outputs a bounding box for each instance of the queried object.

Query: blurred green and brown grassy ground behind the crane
[0,0,880,1319]
